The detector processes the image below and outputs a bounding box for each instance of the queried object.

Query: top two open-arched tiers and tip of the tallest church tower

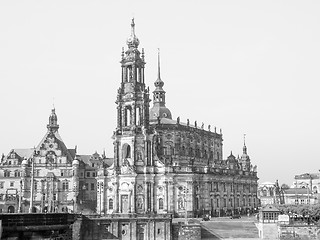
[116,19,149,132]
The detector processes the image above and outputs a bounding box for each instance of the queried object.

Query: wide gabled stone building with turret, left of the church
[0,109,108,213]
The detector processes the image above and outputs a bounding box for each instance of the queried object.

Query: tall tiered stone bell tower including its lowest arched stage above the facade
[113,19,150,169]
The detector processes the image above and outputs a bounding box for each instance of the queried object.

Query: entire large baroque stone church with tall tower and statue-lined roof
[97,20,258,232]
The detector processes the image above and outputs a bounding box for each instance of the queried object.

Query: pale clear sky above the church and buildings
[0,0,320,184]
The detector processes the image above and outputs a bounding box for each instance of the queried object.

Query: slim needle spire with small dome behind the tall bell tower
[150,49,172,120]
